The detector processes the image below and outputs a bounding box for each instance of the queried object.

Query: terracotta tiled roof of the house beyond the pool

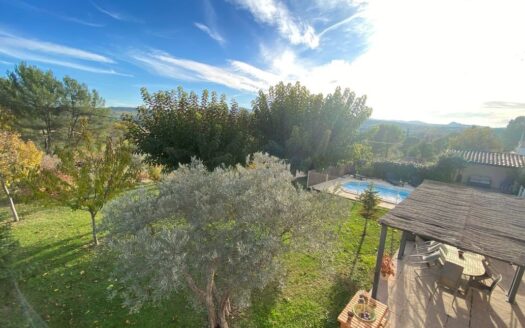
[452,150,525,168]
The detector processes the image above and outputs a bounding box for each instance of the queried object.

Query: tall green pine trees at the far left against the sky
[0,63,110,154]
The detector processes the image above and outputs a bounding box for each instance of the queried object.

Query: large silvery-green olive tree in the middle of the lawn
[102,153,346,328]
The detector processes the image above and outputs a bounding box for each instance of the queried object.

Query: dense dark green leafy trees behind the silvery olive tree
[124,83,372,171]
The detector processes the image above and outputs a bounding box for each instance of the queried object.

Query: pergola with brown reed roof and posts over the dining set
[372,180,525,303]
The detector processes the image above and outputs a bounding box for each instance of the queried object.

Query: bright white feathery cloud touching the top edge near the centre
[230,0,319,49]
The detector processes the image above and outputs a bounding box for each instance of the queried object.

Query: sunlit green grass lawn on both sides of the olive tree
[0,199,399,327]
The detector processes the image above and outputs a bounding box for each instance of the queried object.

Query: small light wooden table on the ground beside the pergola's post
[337,290,388,328]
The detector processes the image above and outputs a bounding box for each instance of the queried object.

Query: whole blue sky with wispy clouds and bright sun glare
[0,0,525,126]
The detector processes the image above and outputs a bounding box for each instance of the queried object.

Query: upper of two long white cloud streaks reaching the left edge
[0,30,114,63]
